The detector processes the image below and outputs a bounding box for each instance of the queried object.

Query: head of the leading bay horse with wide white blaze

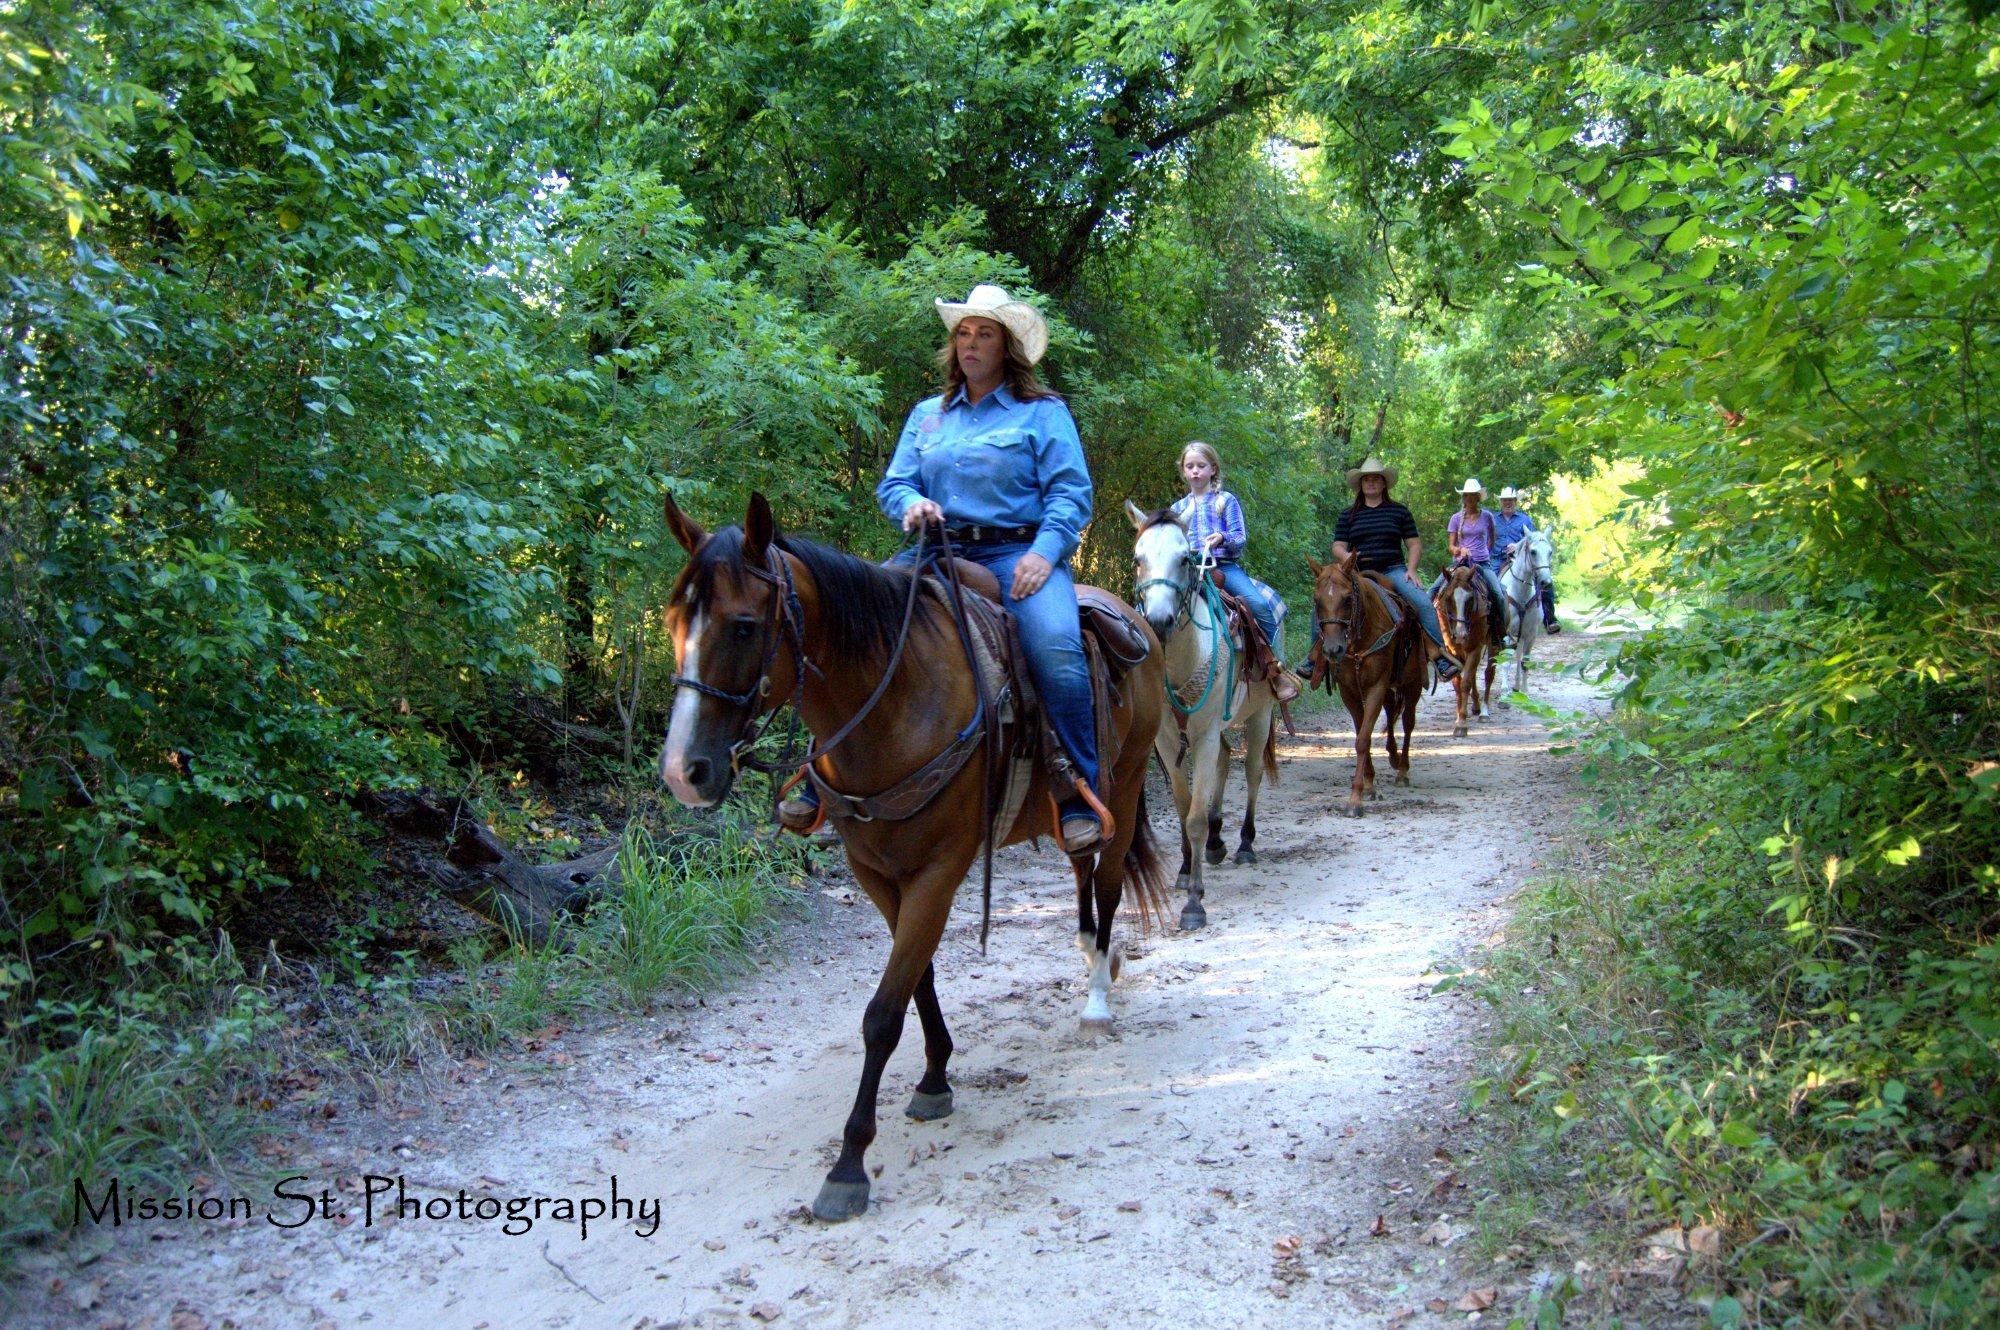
[660,494,800,808]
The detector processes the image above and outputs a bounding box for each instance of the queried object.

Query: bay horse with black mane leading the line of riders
[660,494,1166,1220]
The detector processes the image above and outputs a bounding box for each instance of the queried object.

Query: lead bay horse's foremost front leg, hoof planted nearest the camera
[812,850,972,1222]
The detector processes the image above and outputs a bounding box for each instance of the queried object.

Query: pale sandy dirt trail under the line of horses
[28,634,1588,1330]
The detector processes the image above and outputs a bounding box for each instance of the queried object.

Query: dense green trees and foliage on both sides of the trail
[0,0,2000,1324]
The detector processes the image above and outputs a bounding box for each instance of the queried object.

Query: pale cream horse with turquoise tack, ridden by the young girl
[1126,500,1284,928]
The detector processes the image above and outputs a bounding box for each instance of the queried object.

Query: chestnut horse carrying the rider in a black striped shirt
[1306,554,1428,818]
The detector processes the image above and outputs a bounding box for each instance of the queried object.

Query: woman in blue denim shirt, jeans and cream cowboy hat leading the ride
[780,286,1102,854]
